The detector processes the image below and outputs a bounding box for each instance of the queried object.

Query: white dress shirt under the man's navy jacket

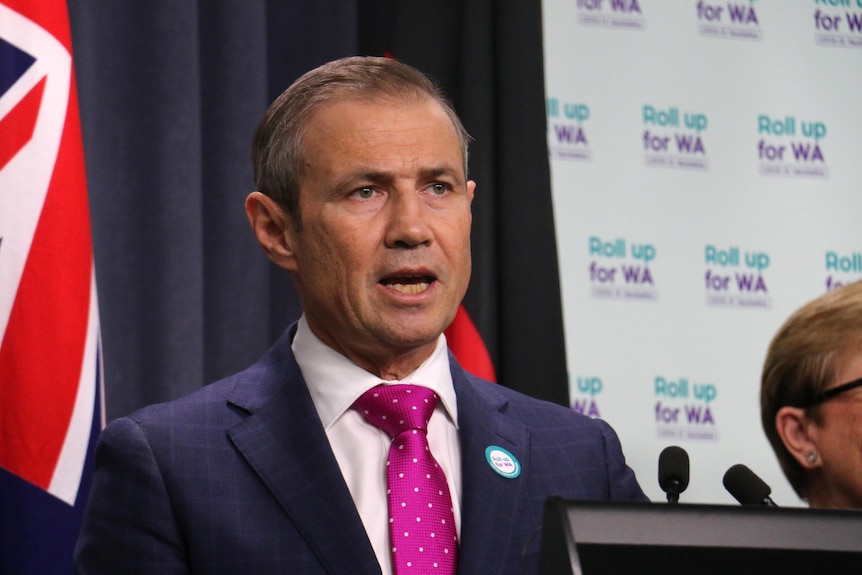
[292,316,461,575]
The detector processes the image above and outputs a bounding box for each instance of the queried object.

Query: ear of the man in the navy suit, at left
[245,192,296,271]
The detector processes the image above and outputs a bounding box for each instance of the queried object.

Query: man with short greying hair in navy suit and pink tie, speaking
[75,57,646,575]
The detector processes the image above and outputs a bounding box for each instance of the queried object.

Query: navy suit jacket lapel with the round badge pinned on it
[450,360,530,573]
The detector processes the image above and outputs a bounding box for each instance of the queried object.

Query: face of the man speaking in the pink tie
[289,99,475,379]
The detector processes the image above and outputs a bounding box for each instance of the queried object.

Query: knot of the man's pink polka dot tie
[354,384,437,437]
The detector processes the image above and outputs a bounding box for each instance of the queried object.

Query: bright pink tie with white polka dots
[354,385,458,575]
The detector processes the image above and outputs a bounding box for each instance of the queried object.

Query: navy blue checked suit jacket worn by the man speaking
[75,329,646,575]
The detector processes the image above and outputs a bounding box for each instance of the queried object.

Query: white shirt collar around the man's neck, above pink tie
[291,314,458,429]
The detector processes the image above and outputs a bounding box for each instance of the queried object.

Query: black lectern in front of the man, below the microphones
[539,498,862,575]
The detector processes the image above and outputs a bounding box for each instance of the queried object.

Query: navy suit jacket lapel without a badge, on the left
[228,333,380,574]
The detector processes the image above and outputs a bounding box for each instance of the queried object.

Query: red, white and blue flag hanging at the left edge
[0,0,104,573]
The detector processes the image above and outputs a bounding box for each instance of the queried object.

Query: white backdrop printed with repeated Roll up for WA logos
[543,0,862,506]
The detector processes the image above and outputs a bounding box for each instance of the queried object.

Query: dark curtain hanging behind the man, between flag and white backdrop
[69,0,567,419]
